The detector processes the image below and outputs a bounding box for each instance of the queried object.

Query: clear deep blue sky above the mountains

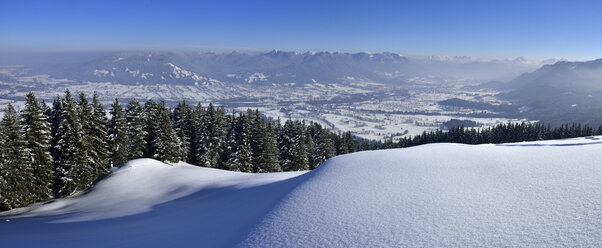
[0,0,602,60]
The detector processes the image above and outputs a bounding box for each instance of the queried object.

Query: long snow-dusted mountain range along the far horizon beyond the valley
[10,50,539,85]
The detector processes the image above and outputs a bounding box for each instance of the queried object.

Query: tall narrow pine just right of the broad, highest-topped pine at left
[88,92,110,180]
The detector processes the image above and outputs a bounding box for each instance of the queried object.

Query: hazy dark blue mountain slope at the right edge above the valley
[489,59,602,125]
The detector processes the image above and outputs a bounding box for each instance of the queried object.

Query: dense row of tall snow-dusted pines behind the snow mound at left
[0,90,357,210]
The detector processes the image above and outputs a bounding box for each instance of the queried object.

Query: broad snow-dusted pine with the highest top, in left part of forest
[55,90,92,196]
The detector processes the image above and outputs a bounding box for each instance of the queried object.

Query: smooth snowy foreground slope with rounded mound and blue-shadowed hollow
[0,136,602,247]
